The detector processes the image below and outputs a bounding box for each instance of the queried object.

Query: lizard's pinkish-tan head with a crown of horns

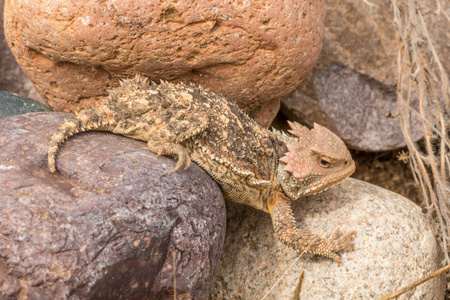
[278,122,355,199]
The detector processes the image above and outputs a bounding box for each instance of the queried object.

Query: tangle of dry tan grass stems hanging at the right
[393,0,450,287]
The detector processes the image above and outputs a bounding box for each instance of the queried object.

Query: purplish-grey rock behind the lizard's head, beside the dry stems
[282,63,423,151]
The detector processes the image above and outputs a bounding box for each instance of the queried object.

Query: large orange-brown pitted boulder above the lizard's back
[5,0,323,125]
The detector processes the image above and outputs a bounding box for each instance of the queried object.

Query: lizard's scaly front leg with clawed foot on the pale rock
[268,192,356,264]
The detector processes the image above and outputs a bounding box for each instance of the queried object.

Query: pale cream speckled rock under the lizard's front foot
[210,179,445,300]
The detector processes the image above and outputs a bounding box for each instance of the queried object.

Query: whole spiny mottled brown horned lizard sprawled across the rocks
[48,76,355,262]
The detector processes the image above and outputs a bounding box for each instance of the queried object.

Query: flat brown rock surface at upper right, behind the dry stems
[317,0,450,86]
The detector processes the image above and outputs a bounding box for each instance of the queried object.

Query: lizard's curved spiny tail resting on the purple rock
[48,109,116,173]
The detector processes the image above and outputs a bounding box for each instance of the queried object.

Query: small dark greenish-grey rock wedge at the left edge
[0,91,50,119]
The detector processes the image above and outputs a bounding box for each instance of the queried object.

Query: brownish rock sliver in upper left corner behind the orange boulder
[0,0,45,103]
